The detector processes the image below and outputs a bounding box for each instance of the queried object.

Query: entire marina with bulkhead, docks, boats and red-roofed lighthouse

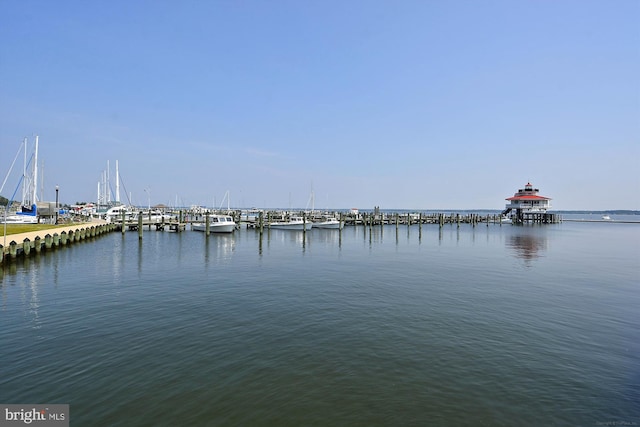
[0,180,634,263]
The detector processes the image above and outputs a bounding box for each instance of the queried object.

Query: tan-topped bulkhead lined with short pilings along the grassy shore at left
[0,223,116,264]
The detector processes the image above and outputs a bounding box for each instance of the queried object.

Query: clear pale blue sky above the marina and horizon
[0,0,640,210]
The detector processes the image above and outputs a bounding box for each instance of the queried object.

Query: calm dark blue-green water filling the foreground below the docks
[0,222,640,426]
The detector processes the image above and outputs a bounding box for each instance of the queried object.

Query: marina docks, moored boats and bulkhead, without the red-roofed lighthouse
[0,208,544,263]
